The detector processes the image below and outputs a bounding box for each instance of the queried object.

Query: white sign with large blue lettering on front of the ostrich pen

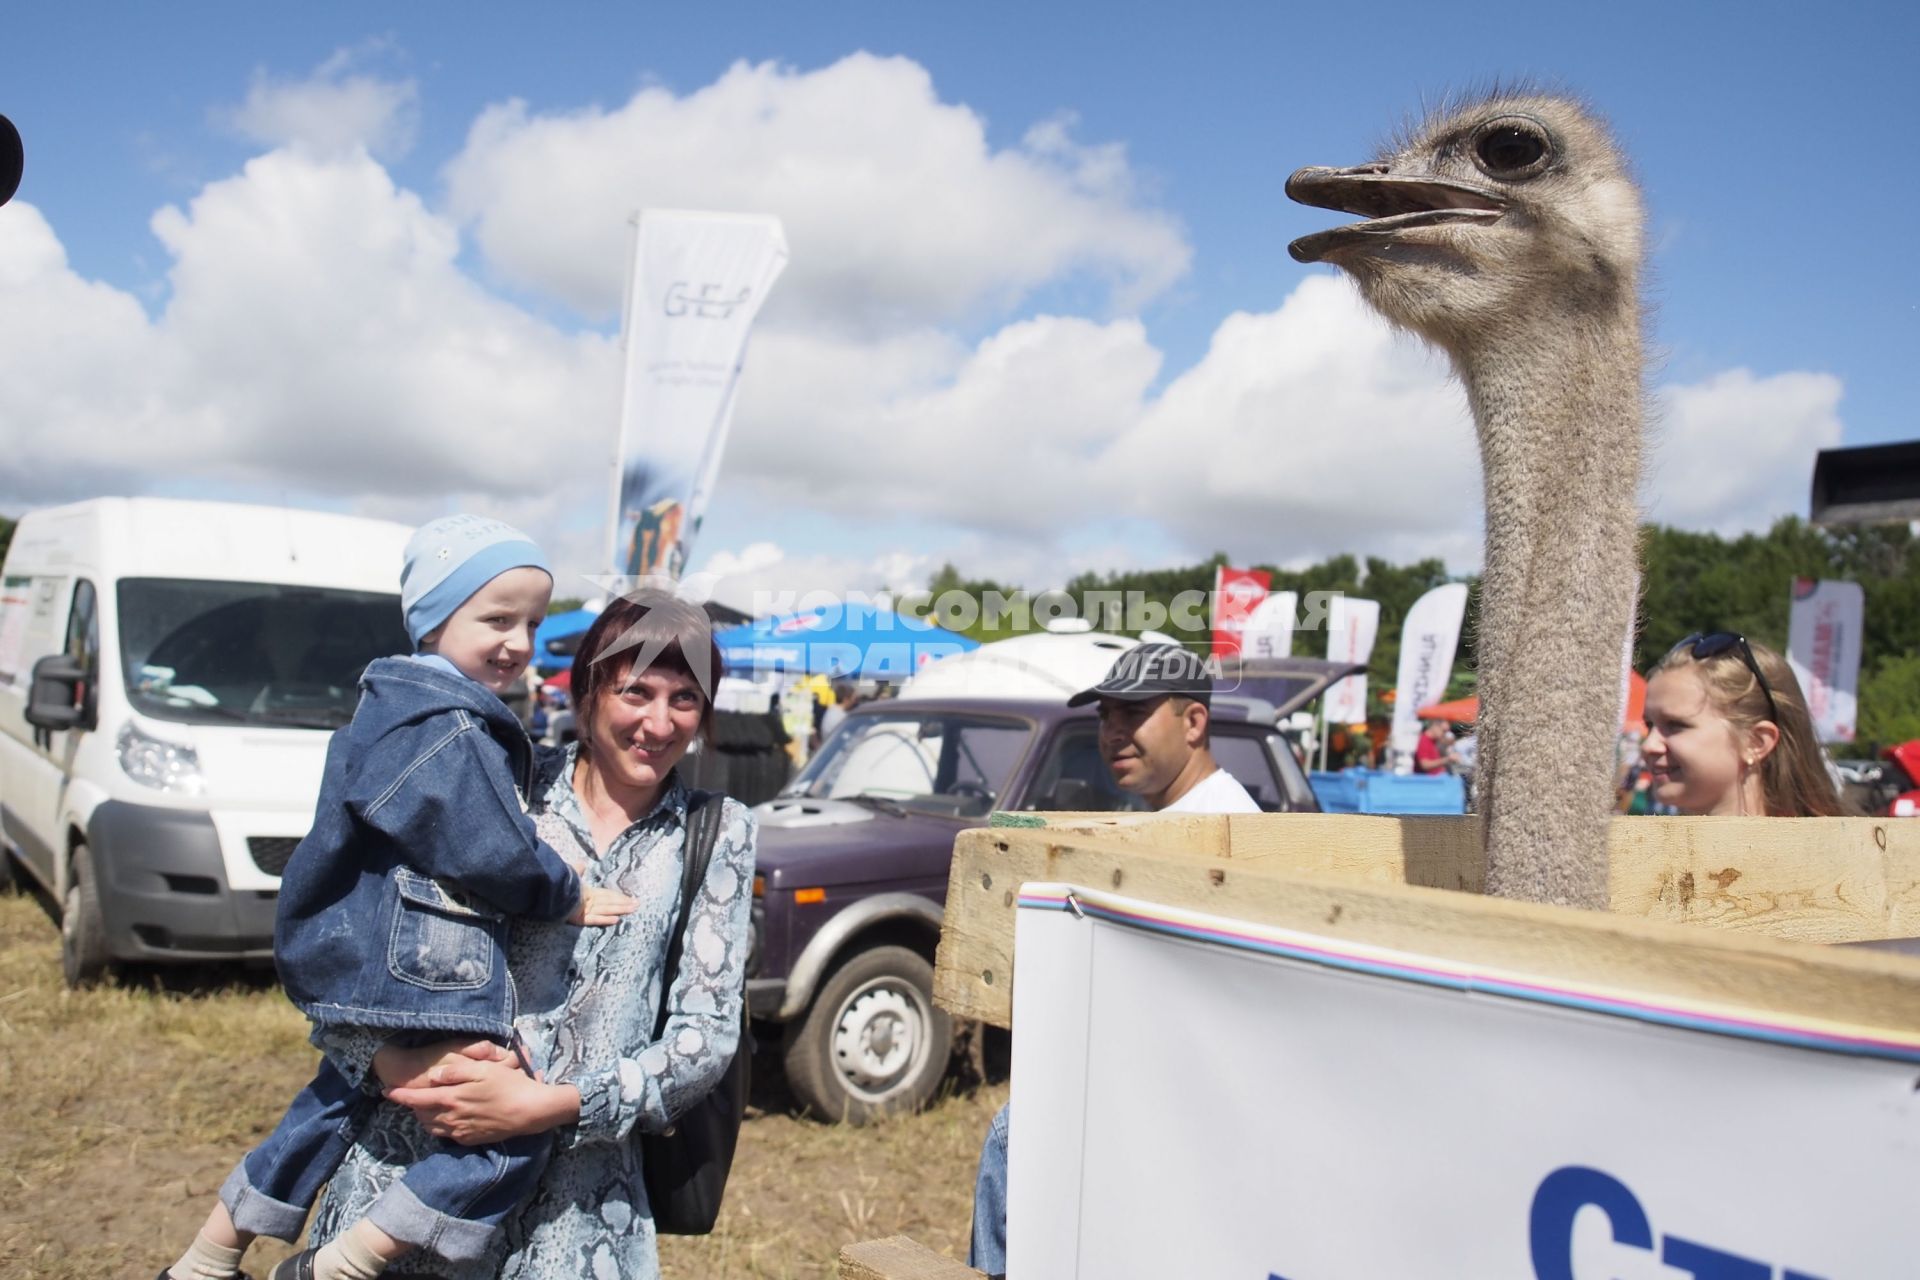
[1008,885,1920,1280]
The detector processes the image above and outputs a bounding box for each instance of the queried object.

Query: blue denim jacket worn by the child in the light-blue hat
[273,658,580,1040]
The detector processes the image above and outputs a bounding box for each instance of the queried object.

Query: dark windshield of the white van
[117,578,413,729]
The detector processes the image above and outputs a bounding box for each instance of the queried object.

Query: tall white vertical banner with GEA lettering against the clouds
[611,209,787,578]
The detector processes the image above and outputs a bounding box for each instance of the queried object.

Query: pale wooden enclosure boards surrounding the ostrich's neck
[839,814,1920,1280]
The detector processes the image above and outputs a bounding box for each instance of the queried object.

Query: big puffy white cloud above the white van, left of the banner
[0,150,618,503]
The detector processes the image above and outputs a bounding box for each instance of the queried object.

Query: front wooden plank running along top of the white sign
[933,832,1920,1032]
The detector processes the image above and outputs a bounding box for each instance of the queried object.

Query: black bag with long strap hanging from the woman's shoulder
[637,791,753,1236]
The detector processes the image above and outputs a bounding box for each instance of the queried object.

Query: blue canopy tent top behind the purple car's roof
[714,603,979,681]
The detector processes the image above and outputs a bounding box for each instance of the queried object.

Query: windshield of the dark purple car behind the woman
[785,710,1033,818]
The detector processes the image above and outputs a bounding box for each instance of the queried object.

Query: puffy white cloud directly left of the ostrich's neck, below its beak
[1100,274,1480,564]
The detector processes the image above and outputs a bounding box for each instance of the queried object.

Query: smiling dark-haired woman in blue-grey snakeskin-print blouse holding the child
[311,595,755,1280]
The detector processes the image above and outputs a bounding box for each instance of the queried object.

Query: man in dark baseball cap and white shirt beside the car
[1068,645,1260,814]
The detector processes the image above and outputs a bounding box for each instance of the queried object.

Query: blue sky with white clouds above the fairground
[0,4,1920,606]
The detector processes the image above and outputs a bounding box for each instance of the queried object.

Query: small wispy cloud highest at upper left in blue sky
[215,44,420,159]
